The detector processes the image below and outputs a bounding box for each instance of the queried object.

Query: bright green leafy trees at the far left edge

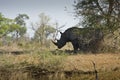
[0,13,29,38]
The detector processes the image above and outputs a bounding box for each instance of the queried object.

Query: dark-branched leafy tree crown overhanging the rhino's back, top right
[74,0,120,31]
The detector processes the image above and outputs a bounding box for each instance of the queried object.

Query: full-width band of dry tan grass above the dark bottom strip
[0,51,120,71]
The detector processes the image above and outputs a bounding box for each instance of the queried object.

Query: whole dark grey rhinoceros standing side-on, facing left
[53,27,103,53]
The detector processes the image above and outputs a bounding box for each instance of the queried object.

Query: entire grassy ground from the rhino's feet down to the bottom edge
[0,45,120,80]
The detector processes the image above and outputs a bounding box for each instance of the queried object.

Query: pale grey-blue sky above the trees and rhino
[0,0,78,36]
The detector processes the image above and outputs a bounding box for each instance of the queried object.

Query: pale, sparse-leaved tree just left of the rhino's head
[32,13,55,45]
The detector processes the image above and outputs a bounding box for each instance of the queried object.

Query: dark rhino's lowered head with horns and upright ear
[52,32,67,49]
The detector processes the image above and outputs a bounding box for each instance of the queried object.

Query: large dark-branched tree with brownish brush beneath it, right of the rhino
[74,0,120,52]
